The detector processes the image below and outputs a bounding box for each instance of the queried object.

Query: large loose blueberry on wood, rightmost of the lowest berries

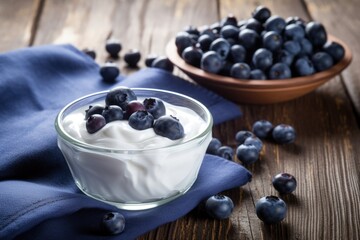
[255,196,287,224]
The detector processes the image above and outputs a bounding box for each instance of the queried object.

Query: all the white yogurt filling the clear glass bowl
[58,98,211,206]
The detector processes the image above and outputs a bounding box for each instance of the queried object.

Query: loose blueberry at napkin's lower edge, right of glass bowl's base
[205,194,234,219]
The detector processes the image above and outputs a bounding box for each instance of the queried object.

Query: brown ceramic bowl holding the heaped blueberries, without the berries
[166,36,352,104]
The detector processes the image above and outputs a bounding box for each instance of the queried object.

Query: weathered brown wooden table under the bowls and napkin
[0,0,360,239]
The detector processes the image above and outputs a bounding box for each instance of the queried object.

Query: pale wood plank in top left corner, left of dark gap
[0,0,41,52]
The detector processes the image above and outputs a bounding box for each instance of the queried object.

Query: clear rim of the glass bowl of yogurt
[55,88,213,154]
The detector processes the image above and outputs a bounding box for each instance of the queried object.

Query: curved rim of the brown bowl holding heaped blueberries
[166,34,352,89]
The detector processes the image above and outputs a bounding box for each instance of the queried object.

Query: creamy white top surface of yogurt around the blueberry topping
[63,99,206,150]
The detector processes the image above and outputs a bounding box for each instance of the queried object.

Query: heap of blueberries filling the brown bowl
[175,6,345,80]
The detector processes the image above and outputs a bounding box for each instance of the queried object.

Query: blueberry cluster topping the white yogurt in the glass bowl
[85,86,185,140]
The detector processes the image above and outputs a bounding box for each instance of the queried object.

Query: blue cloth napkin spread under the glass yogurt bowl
[0,45,251,239]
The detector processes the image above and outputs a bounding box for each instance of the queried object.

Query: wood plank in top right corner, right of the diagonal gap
[304,0,360,120]
